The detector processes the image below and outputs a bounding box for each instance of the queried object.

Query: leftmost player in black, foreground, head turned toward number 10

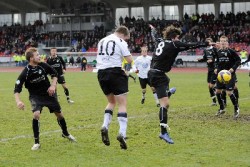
[14,48,76,150]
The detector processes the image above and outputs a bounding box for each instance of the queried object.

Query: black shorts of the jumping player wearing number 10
[97,67,128,95]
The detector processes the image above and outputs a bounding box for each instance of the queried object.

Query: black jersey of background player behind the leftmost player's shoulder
[47,55,66,76]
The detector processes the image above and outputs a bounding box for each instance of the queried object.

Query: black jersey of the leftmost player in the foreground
[14,62,57,95]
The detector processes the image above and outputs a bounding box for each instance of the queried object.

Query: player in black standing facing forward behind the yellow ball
[215,36,241,119]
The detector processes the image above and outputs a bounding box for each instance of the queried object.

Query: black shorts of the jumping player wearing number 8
[148,70,170,99]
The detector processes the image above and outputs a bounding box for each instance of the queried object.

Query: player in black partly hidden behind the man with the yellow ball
[198,38,217,106]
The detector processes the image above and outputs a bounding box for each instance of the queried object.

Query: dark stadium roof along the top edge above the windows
[0,0,247,14]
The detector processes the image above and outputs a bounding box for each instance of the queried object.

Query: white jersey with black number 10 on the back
[96,34,131,69]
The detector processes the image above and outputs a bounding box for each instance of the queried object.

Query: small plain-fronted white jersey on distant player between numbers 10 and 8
[134,56,152,78]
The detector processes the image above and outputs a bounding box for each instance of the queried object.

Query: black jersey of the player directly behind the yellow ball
[215,49,241,71]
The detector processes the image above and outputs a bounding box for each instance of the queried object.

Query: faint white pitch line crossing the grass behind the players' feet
[0,97,250,142]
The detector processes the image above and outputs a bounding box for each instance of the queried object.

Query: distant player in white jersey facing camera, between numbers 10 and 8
[134,46,176,107]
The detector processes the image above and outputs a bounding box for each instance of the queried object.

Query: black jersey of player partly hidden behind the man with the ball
[199,47,216,71]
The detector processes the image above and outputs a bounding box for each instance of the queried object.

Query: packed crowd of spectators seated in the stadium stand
[0,1,250,66]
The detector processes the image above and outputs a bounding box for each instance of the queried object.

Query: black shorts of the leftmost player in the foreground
[29,95,61,113]
